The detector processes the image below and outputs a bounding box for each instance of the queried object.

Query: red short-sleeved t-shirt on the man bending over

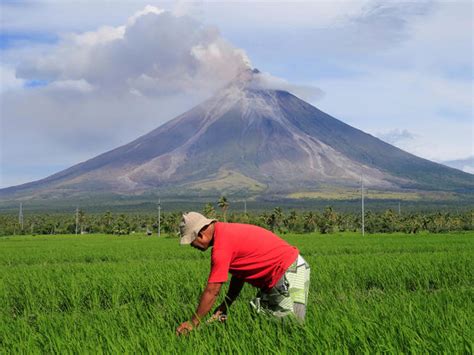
[208,222,299,289]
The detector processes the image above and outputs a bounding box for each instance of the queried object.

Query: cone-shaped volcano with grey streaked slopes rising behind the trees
[0,69,474,198]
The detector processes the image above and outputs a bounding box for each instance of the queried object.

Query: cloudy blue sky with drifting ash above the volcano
[0,0,474,187]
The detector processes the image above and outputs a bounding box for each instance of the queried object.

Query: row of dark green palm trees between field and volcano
[0,197,474,236]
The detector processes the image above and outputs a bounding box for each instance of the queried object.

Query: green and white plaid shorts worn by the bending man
[250,255,311,321]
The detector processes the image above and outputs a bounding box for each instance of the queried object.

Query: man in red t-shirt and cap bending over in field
[176,212,310,335]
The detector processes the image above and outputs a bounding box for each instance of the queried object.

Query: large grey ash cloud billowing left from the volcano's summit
[16,6,250,96]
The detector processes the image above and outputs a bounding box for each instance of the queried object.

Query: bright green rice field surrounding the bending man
[0,232,474,354]
